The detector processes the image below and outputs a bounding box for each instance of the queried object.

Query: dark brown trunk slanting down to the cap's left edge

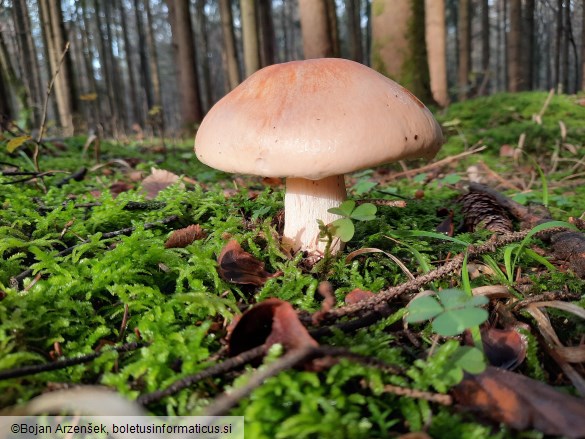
[169,0,203,134]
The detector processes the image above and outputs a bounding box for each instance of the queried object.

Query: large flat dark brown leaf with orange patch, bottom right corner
[452,366,585,438]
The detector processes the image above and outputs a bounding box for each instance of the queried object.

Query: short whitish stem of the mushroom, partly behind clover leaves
[284,175,347,254]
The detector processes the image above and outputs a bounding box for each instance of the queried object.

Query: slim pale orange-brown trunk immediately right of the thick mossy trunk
[425,0,449,107]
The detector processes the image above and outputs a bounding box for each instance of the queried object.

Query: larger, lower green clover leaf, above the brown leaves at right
[406,288,488,337]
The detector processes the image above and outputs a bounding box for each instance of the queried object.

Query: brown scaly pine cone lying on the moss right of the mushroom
[458,192,513,233]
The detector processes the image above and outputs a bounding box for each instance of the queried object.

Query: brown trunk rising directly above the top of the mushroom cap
[299,0,334,59]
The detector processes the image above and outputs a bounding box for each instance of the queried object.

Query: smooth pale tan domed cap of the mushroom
[195,58,443,180]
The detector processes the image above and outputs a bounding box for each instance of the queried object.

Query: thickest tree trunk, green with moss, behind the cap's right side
[371,0,433,103]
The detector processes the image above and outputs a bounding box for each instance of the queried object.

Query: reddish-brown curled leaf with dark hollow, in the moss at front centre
[229,298,318,356]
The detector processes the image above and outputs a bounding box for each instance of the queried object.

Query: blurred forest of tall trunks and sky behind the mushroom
[0,0,585,137]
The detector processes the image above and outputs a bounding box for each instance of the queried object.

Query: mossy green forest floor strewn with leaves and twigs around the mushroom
[0,92,585,438]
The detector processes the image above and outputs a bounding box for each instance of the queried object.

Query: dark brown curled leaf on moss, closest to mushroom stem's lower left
[217,239,282,287]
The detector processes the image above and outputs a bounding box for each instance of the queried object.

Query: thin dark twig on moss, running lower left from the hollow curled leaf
[136,345,266,405]
